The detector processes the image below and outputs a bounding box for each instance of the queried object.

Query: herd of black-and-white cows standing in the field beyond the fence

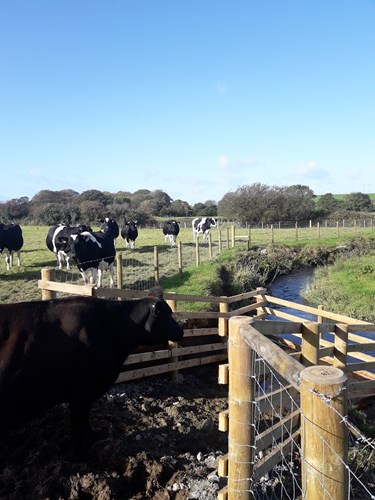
[0,217,216,287]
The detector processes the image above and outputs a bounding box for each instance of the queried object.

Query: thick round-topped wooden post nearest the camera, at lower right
[300,366,348,500]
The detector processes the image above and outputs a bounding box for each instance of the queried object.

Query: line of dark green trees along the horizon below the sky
[0,183,374,226]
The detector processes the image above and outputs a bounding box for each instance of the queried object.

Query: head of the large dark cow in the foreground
[130,287,184,345]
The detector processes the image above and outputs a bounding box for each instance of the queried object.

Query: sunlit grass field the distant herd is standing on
[0,226,375,302]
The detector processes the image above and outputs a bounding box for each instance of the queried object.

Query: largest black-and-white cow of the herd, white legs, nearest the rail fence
[66,219,118,287]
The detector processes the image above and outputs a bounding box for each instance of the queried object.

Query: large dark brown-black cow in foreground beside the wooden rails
[0,288,183,446]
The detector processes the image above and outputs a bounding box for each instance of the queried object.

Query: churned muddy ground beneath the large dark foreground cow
[0,366,228,500]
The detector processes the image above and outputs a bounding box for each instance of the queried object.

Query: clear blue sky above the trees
[0,0,375,204]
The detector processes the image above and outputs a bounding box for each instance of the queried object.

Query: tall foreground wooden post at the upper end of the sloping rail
[228,316,255,500]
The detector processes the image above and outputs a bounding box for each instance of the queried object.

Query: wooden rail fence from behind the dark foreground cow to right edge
[38,268,375,392]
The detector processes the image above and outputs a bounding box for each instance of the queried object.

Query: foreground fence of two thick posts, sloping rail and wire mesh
[218,317,349,500]
